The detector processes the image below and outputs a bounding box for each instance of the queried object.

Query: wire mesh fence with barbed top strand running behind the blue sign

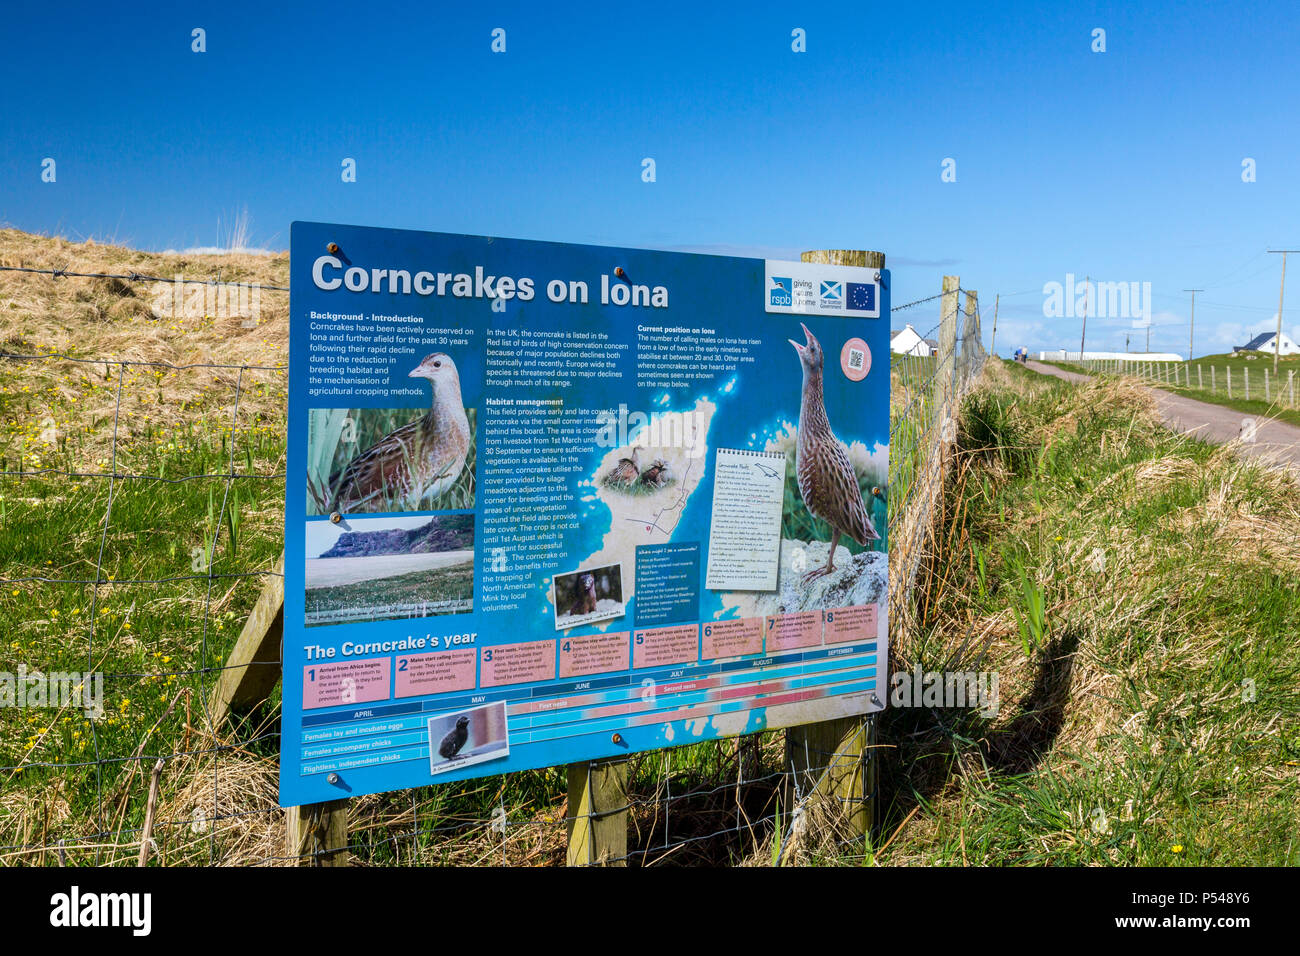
[0,265,987,865]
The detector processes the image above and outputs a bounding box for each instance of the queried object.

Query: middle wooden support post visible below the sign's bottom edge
[567,760,628,866]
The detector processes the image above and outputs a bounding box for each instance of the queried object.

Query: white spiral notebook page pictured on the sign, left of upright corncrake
[705,449,785,591]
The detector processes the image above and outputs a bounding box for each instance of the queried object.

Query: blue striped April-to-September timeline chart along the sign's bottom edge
[300,641,879,775]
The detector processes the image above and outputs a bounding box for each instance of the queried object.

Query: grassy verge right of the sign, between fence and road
[881,369,1300,866]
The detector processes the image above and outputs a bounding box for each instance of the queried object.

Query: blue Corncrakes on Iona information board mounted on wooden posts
[280,222,889,806]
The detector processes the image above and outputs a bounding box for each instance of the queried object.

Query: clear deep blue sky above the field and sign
[0,0,1300,354]
